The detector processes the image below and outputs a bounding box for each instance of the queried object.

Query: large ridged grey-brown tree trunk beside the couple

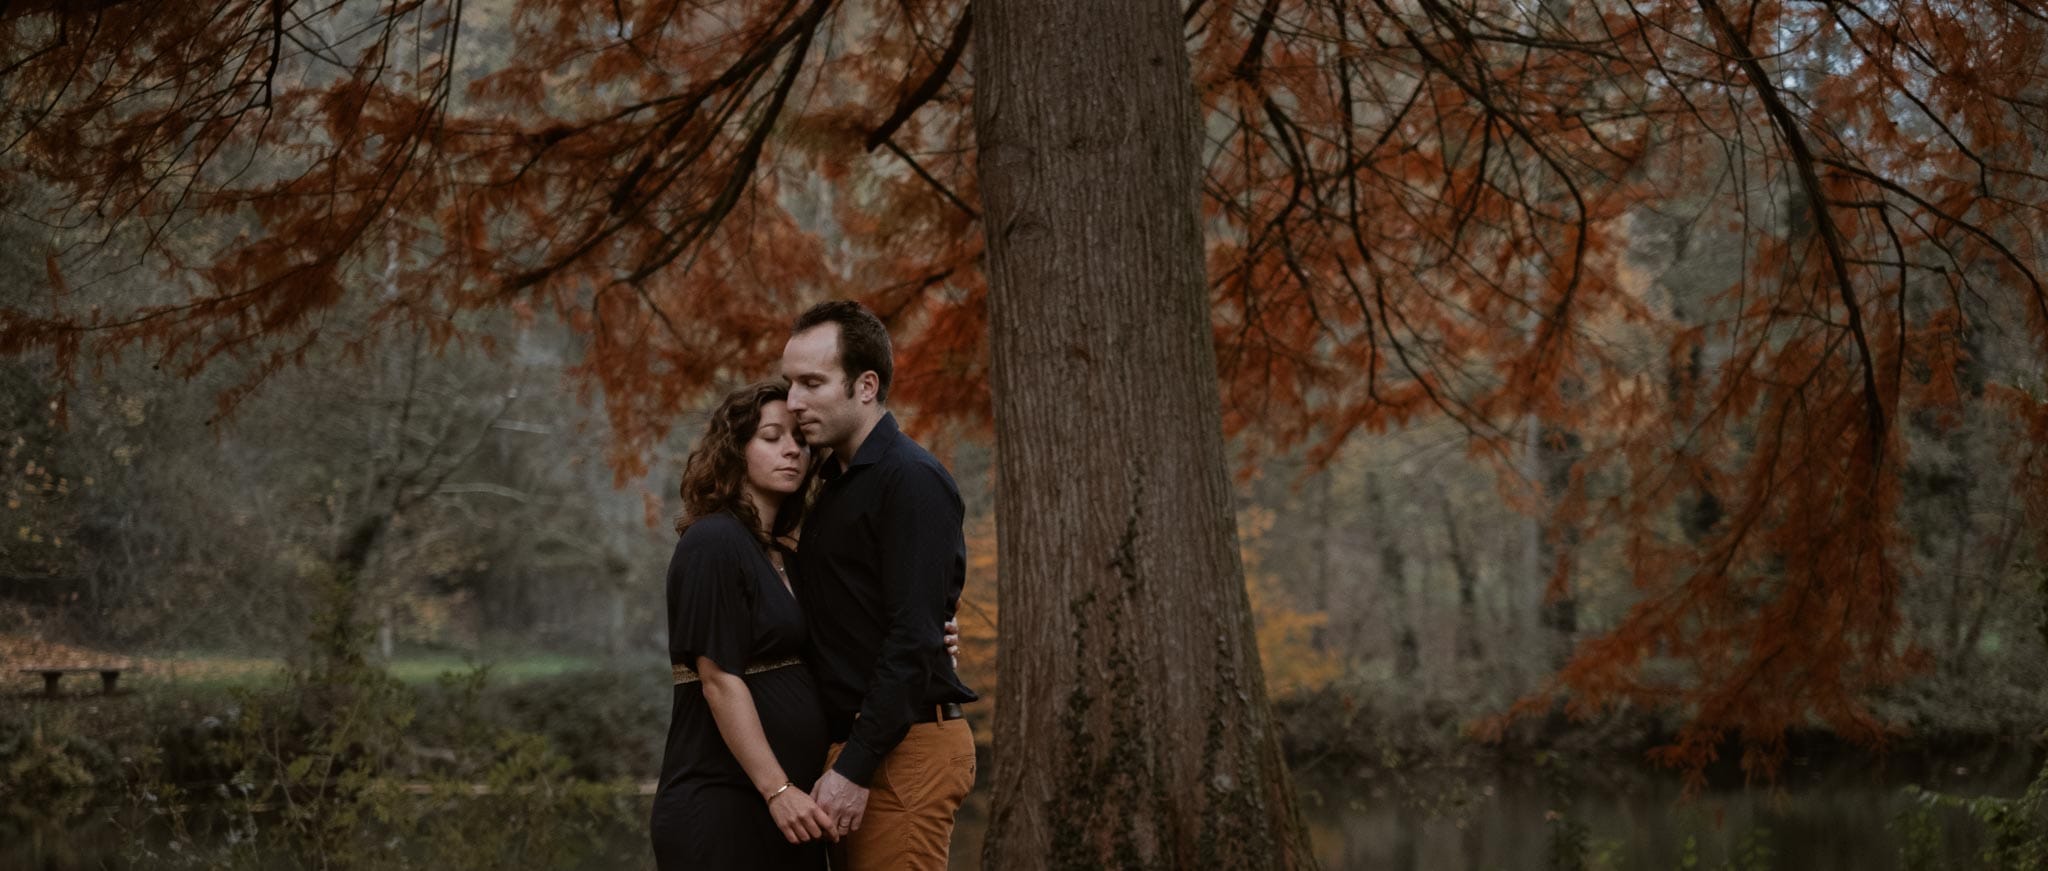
[975,0,1313,869]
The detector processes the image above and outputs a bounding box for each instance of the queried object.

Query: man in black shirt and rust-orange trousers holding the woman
[782,299,977,871]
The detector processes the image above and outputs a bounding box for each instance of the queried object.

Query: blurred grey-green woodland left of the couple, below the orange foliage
[0,297,668,658]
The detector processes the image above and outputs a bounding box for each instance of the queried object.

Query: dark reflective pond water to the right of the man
[950,762,2032,871]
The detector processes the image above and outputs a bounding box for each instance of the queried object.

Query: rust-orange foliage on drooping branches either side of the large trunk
[0,0,2048,766]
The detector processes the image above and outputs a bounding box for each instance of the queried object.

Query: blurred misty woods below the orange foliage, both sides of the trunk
[0,212,2048,754]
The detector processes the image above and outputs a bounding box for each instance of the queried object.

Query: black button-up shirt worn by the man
[797,414,977,787]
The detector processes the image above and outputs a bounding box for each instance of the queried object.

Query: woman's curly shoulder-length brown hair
[676,381,811,545]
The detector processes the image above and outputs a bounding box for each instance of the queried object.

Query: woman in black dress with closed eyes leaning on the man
[653,383,831,871]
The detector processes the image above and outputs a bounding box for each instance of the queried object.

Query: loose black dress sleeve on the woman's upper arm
[668,521,754,674]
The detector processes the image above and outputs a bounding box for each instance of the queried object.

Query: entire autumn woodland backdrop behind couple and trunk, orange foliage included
[0,0,2048,867]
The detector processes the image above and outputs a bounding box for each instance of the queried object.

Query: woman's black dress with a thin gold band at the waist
[651,514,825,871]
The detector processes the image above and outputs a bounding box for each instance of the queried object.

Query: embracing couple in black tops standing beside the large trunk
[651,301,975,871]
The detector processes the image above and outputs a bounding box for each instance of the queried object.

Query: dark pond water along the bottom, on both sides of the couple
[0,752,2038,871]
